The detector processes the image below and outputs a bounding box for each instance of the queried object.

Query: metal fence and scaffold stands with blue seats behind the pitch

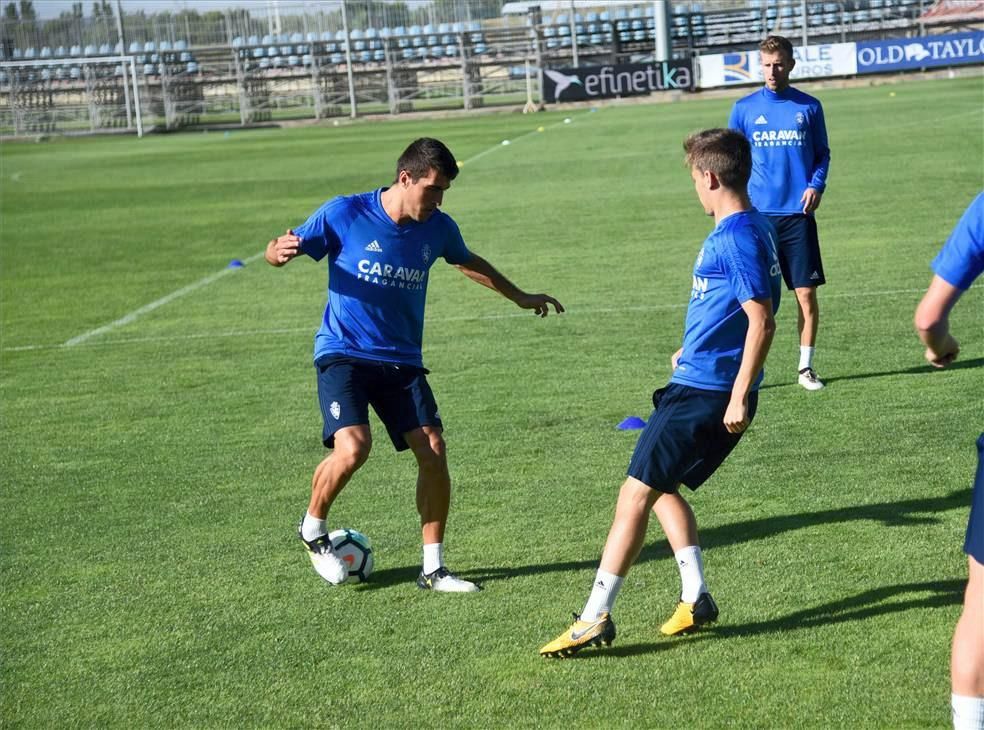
[0,0,964,135]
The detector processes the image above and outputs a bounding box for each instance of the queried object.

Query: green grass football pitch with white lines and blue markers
[0,77,984,728]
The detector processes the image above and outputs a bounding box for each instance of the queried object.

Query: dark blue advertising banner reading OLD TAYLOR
[857,30,984,74]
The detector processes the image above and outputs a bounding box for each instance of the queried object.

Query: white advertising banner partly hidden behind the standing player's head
[699,43,858,89]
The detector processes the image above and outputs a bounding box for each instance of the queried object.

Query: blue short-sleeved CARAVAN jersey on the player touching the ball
[294,188,471,367]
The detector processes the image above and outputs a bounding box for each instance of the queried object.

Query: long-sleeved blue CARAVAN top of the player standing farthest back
[728,87,830,215]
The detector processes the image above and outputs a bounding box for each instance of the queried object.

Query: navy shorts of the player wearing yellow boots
[628,383,758,494]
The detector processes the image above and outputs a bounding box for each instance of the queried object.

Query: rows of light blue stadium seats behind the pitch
[0,0,963,86]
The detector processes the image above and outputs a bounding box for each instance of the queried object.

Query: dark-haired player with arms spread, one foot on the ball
[266,138,564,593]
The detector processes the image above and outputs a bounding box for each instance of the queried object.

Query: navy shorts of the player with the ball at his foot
[314,355,443,451]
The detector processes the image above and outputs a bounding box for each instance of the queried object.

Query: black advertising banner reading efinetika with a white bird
[543,61,694,104]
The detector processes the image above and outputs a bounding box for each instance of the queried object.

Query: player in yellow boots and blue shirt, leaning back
[540,129,781,656]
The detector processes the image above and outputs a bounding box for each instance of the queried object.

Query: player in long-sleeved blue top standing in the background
[728,36,830,390]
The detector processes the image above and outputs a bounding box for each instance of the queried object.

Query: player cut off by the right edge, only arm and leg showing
[915,193,984,730]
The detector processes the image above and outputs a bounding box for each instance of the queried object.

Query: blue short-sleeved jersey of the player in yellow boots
[670,210,782,391]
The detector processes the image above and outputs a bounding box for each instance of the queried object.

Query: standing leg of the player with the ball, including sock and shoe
[404,426,479,593]
